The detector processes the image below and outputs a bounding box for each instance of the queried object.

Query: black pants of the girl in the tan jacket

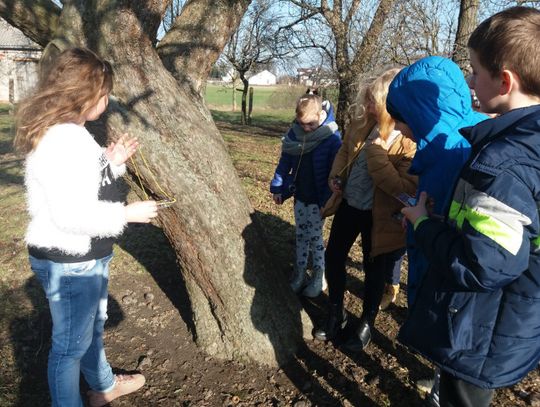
[325,200,372,309]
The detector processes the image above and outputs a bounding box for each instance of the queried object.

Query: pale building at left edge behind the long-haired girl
[0,18,42,103]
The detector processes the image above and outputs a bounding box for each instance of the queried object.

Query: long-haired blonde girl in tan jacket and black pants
[315,69,416,350]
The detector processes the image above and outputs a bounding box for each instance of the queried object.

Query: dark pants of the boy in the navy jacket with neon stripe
[439,371,495,407]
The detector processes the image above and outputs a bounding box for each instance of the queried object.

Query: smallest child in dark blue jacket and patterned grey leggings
[270,94,341,297]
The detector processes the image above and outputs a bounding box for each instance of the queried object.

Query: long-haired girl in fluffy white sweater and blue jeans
[14,48,157,407]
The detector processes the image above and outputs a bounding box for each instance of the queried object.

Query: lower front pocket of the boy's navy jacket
[447,292,476,350]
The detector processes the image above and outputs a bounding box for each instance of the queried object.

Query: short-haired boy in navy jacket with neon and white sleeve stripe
[399,7,540,407]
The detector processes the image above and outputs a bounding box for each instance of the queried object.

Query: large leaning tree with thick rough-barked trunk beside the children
[0,0,309,364]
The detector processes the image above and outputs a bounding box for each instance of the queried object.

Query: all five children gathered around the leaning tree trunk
[15,3,540,407]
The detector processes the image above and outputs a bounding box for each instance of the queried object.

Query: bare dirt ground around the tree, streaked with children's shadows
[0,113,540,407]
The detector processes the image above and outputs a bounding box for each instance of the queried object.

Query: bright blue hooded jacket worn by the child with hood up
[386,57,487,305]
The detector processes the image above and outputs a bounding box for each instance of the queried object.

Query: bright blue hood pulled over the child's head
[386,56,487,174]
